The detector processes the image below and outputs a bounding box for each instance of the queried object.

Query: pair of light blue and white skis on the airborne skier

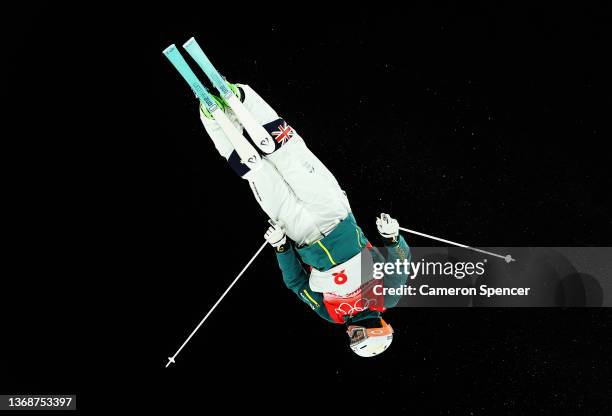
[163,37,275,169]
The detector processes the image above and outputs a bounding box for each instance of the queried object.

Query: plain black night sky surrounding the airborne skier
[2,3,612,415]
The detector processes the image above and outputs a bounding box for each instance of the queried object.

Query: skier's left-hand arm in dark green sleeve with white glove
[265,220,332,321]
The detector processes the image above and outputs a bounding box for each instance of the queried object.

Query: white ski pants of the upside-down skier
[201,85,351,245]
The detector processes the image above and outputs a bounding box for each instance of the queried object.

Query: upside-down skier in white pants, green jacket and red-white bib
[200,83,410,357]
